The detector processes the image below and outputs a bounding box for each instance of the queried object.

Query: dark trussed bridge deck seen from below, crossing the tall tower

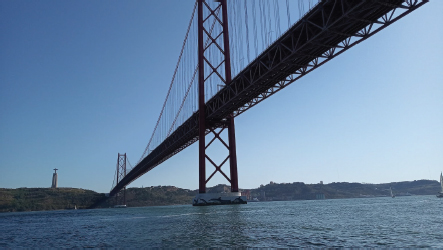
[110,0,427,195]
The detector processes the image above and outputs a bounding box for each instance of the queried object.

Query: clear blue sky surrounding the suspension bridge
[0,0,443,192]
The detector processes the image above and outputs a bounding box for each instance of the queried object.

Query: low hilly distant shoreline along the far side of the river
[0,180,440,212]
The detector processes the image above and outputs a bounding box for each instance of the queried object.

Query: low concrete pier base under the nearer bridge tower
[192,192,248,206]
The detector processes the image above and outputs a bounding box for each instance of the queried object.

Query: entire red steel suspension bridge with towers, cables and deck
[110,0,427,196]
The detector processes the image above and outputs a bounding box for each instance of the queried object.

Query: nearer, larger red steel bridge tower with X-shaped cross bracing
[193,0,246,205]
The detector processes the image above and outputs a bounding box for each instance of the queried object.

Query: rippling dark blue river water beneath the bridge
[0,196,443,248]
